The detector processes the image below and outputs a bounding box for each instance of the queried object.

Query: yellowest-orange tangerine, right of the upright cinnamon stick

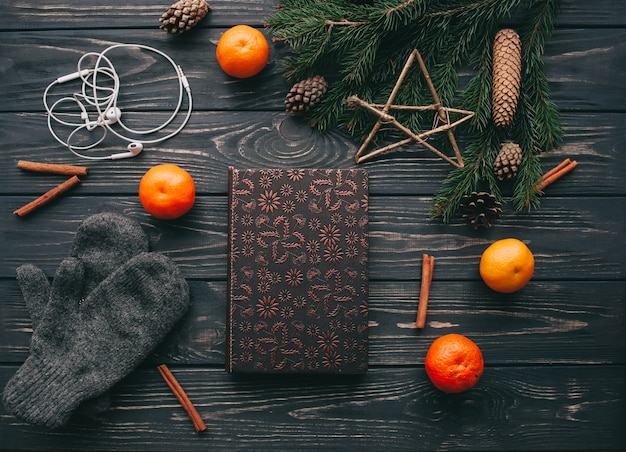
[480,238,535,293]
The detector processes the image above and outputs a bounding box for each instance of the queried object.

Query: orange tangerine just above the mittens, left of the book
[139,164,196,220]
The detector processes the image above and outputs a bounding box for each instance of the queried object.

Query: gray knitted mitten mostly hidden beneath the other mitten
[16,212,149,414]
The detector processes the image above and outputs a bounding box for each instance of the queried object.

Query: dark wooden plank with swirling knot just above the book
[0,111,626,196]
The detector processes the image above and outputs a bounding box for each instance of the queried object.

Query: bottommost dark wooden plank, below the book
[0,366,626,451]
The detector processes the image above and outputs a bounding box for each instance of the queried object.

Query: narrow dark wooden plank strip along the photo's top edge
[0,0,626,31]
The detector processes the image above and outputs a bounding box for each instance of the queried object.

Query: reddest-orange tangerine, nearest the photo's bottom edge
[424,334,485,394]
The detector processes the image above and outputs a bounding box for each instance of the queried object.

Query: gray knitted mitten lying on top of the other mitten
[3,253,189,428]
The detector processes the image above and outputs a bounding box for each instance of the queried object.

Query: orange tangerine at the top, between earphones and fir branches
[215,25,270,78]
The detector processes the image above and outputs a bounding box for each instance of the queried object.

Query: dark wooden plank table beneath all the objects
[0,0,626,451]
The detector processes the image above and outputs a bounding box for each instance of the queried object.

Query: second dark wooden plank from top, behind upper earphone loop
[0,28,626,112]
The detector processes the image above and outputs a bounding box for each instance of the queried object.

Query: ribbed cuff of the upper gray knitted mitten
[2,355,97,429]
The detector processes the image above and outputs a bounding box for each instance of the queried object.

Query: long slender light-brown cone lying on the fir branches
[491,28,522,127]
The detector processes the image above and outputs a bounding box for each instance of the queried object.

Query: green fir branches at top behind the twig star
[266,0,563,222]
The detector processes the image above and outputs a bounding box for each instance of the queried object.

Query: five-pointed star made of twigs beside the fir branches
[346,49,474,168]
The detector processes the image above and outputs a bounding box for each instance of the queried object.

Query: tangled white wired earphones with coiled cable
[43,44,192,160]
